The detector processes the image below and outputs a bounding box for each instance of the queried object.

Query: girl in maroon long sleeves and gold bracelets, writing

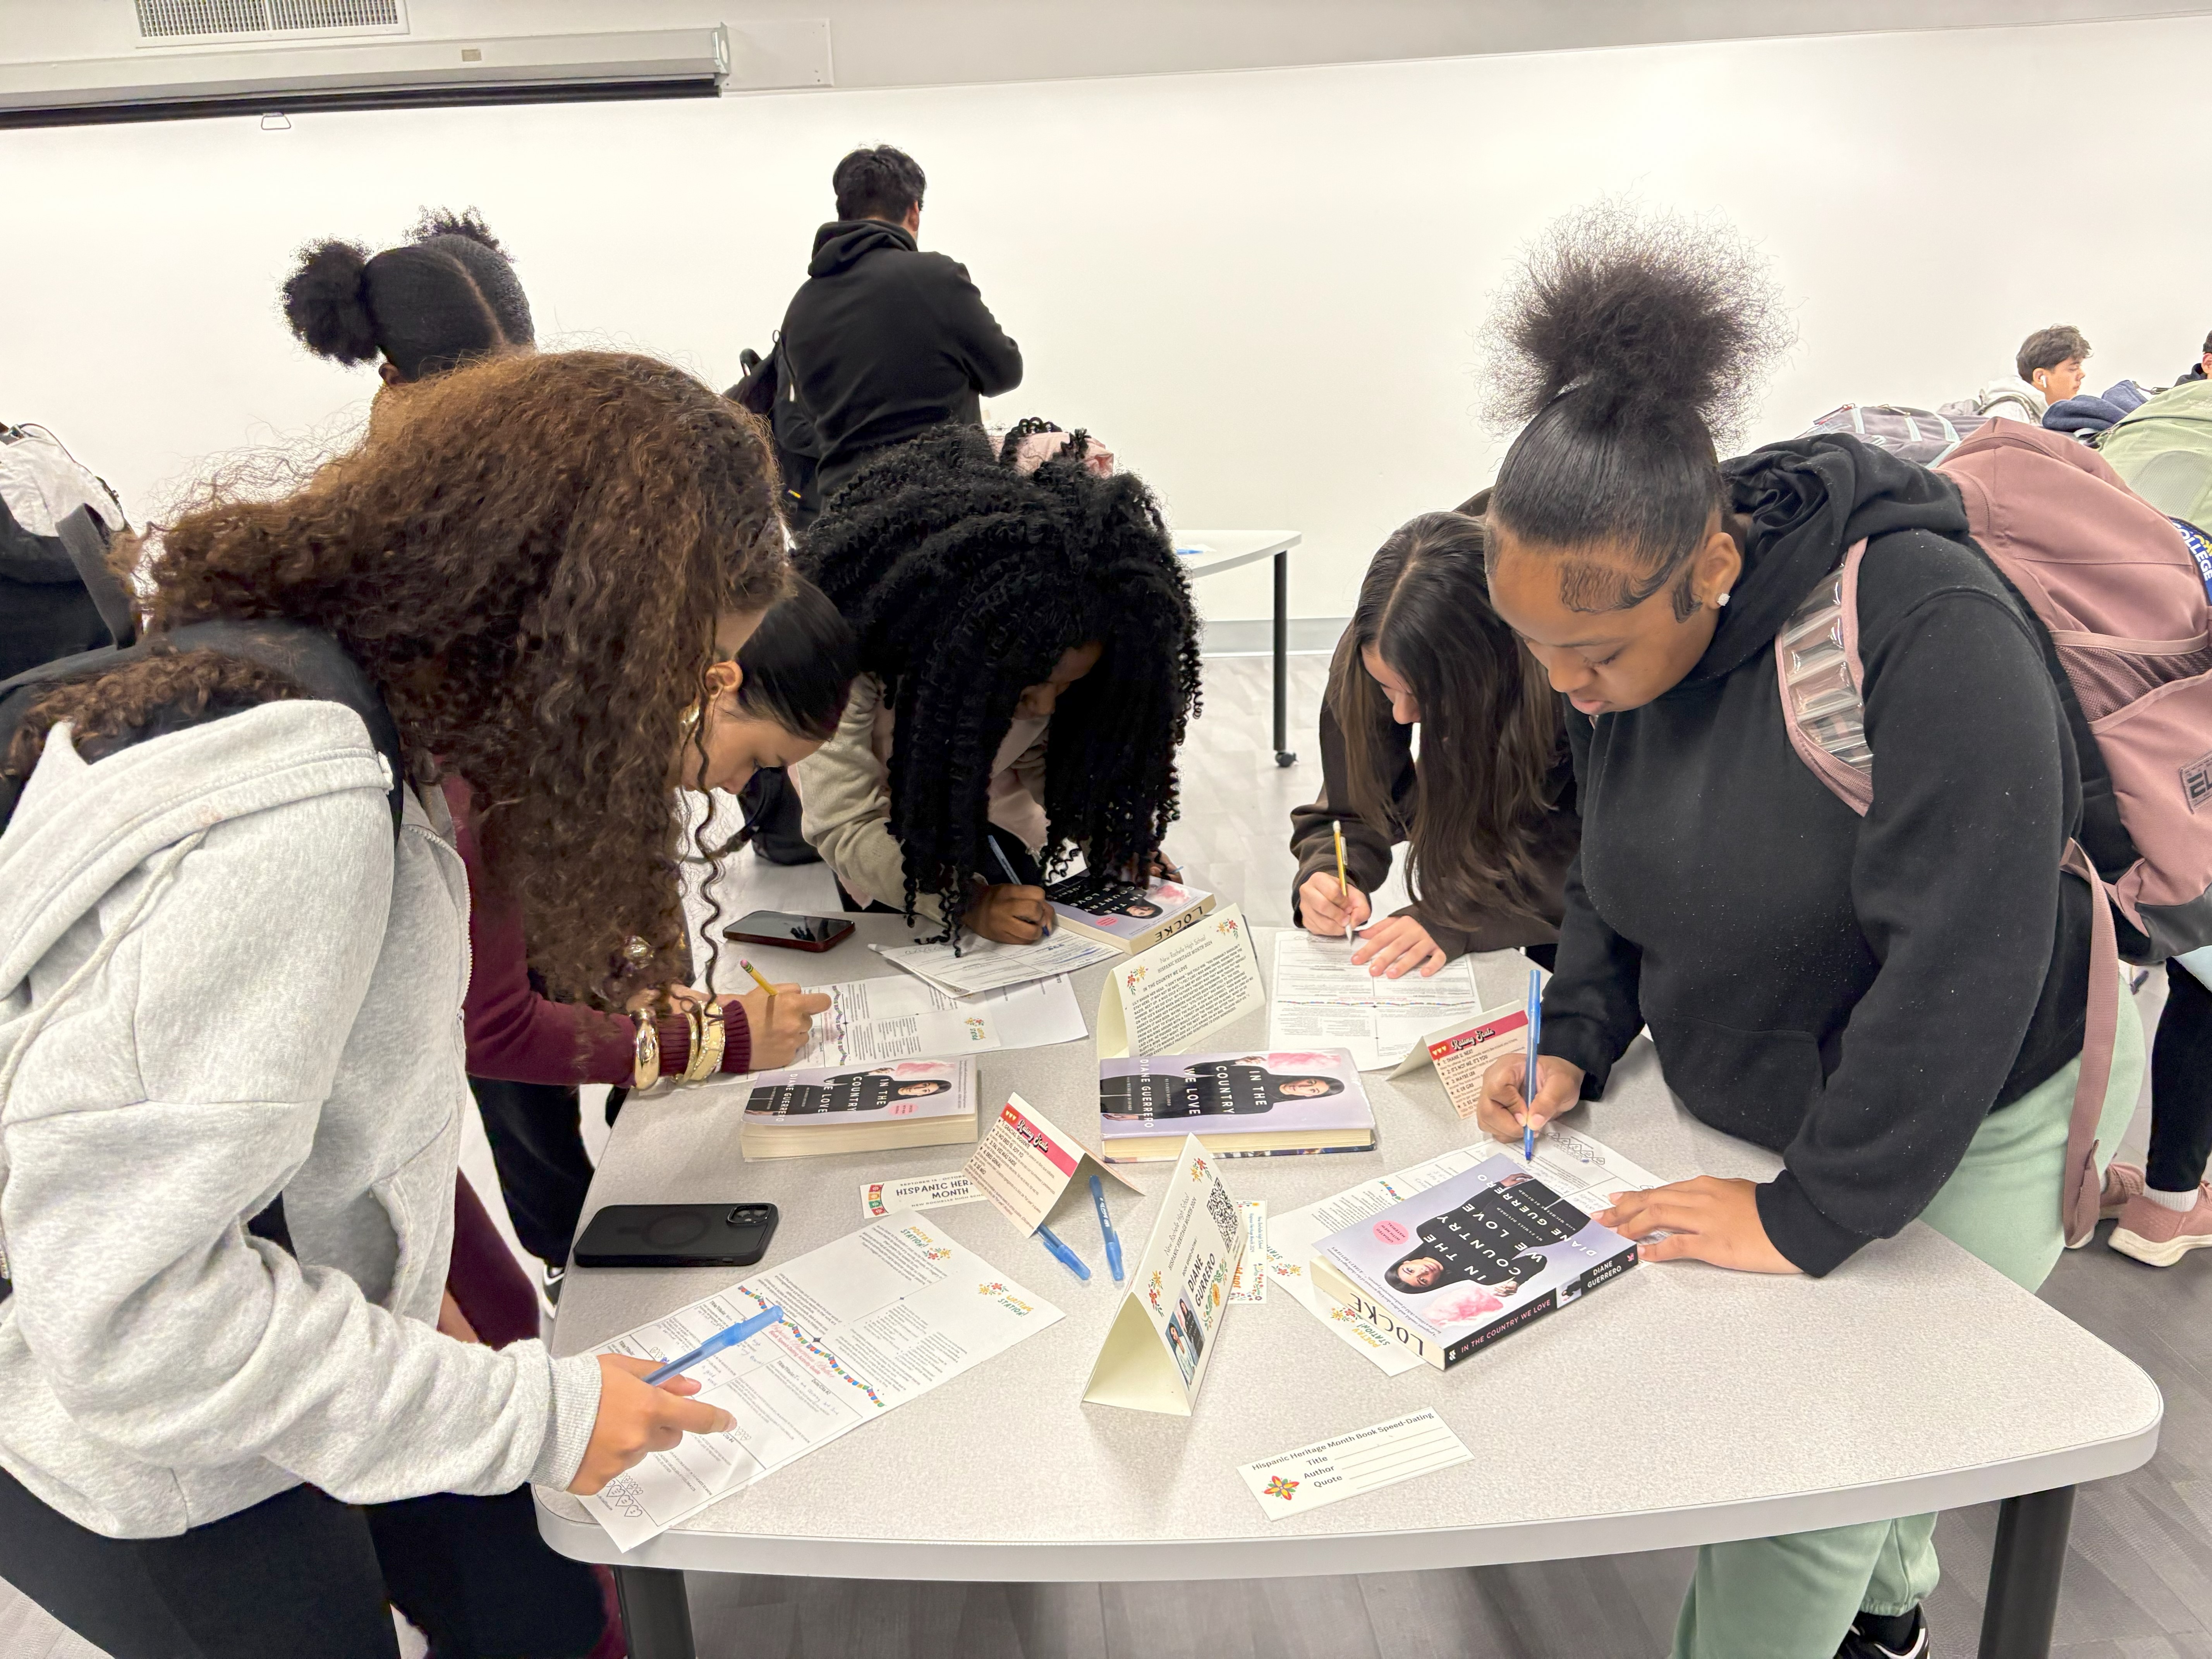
[445,573,852,1279]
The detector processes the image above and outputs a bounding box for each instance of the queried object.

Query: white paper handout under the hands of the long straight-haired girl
[1267,929,1482,1071]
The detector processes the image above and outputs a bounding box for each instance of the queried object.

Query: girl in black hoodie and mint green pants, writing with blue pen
[1482,208,2143,1659]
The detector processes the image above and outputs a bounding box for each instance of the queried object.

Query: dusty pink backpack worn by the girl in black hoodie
[1774,418,2212,1243]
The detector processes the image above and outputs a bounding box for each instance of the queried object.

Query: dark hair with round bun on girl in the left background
[283,208,538,380]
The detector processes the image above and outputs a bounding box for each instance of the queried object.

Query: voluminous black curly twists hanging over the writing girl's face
[799,427,1199,938]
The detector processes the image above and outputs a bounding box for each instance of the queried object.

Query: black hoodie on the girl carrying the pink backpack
[1542,436,2088,1274]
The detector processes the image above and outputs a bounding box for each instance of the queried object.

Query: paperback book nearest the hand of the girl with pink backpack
[1310,1152,1637,1371]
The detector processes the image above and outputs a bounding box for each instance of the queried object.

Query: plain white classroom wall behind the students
[0,18,2212,617]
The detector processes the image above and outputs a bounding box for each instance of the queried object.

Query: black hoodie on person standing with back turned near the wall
[783,219,1022,500]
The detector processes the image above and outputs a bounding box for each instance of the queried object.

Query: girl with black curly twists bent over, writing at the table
[792,427,1199,945]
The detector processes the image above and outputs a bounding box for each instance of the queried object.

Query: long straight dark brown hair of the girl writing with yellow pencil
[1329,513,1562,927]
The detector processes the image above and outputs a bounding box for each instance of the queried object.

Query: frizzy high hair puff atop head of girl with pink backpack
[1489,201,1794,449]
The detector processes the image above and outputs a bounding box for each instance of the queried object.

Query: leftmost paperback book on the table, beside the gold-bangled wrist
[739,1060,975,1159]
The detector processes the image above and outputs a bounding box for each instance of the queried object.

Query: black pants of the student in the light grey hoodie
[0,1471,606,1659]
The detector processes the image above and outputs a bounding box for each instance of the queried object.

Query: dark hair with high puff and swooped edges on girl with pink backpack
[1489,201,1792,615]
